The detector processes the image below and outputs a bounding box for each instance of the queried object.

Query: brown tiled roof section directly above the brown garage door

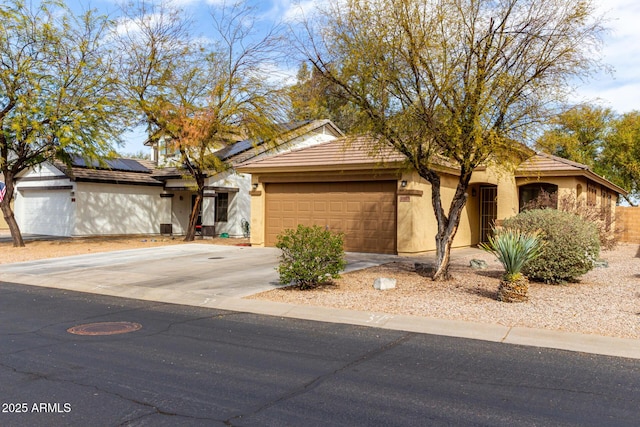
[237,136,406,171]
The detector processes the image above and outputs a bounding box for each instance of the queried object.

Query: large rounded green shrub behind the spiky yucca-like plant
[503,209,600,283]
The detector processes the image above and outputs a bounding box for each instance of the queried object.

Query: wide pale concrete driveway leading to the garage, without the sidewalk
[0,244,408,305]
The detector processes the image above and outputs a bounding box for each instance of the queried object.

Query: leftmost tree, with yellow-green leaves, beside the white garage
[0,0,124,246]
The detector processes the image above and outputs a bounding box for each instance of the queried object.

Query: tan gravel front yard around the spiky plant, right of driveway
[250,244,640,339]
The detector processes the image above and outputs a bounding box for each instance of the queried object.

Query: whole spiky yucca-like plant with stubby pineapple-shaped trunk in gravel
[480,229,543,302]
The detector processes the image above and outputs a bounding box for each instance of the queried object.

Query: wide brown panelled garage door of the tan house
[266,181,396,253]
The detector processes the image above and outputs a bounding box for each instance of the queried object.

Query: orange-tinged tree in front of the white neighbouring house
[115,1,283,241]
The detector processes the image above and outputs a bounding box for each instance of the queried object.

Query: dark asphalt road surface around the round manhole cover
[0,283,640,426]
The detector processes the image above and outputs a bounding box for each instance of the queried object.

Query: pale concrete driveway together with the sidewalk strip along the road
[0,244,640,359]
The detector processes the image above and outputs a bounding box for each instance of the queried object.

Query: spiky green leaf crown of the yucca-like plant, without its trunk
[480,228,544,281]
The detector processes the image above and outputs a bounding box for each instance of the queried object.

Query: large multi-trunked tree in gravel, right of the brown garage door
[297,0,602,280]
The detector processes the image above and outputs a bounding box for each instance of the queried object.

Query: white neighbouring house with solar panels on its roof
[14,120,343,237]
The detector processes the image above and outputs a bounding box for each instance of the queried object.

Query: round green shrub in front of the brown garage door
[276,225,346,289]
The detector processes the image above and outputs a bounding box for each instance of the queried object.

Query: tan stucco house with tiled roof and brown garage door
[236,137,625,255]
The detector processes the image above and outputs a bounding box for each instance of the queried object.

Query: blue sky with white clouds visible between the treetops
[67,0,640,154]
